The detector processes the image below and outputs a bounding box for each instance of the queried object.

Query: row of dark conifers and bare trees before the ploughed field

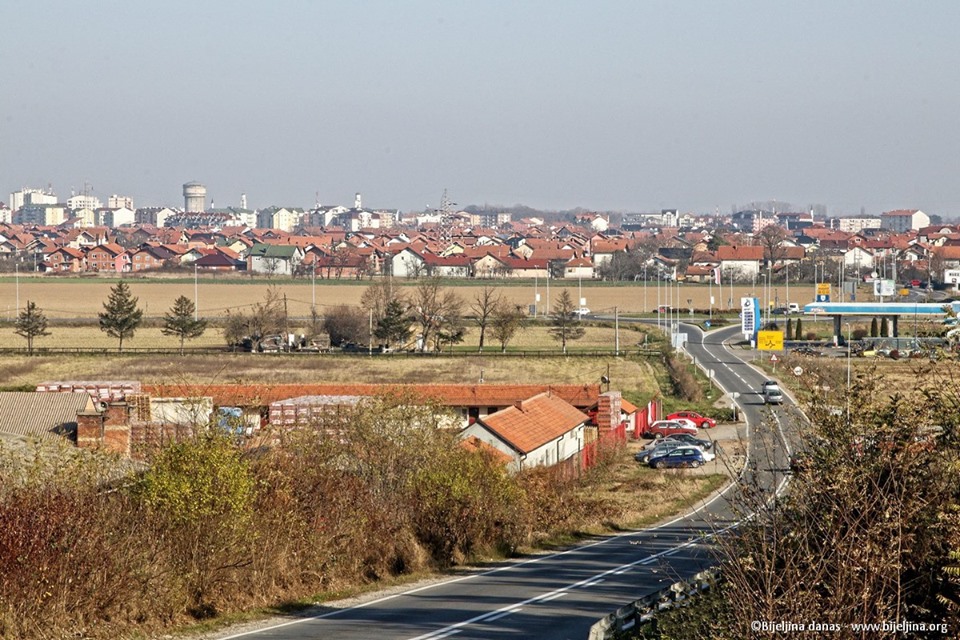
[14,278,584,354]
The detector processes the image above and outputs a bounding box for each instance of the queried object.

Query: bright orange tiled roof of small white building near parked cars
[479,392,589,453]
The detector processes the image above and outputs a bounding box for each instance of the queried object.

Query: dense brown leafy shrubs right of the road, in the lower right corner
[633,362,960,640]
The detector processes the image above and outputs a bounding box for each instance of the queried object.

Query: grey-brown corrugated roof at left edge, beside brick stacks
[0,391,94,438]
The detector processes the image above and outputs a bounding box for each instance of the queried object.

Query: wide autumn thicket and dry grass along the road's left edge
[0,390,722,639]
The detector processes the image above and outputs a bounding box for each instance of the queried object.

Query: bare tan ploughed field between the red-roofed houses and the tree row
[0,275,828,320]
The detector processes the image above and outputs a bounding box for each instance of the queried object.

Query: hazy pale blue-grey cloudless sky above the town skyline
[0,0,960,217]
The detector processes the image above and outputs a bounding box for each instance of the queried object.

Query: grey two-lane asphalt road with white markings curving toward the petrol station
[210,325,791,640]
